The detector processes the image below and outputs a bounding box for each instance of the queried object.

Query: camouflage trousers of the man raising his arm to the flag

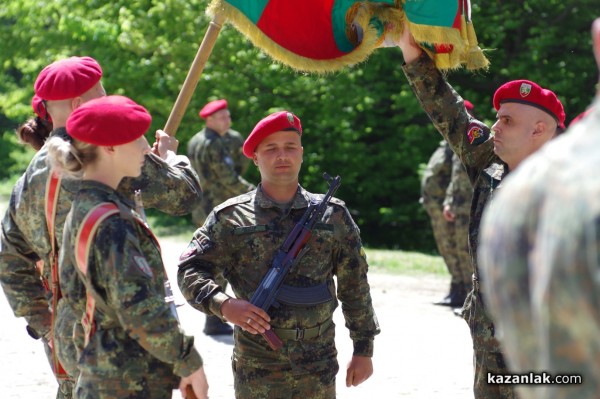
[463,284,517,399]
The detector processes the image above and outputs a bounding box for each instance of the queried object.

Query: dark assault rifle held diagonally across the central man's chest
[250,173,342,350]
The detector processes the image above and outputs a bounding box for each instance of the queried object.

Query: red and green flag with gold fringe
[208,0,487,72]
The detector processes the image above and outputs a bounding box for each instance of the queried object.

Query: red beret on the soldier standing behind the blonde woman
[34,57,102,101]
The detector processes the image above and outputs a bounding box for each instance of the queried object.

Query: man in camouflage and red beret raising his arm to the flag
[399,26,565,399]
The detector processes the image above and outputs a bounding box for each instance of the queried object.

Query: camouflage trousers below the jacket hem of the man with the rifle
[232,361,336,399]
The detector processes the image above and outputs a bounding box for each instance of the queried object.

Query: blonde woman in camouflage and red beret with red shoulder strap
[46,96,208,399]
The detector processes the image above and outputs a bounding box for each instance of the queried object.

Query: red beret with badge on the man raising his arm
[494,80,565,129]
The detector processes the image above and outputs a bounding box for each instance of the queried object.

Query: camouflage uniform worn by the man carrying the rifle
[178,185,379,398]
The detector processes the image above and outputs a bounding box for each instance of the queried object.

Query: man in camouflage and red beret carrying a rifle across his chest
[178,111,379,399]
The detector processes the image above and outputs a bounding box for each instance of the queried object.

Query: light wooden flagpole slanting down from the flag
[163,13,225,136]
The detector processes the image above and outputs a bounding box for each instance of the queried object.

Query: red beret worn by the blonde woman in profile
[67,96,152,147]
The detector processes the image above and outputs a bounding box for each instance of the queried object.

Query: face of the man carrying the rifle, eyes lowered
[253,131,304,184]
